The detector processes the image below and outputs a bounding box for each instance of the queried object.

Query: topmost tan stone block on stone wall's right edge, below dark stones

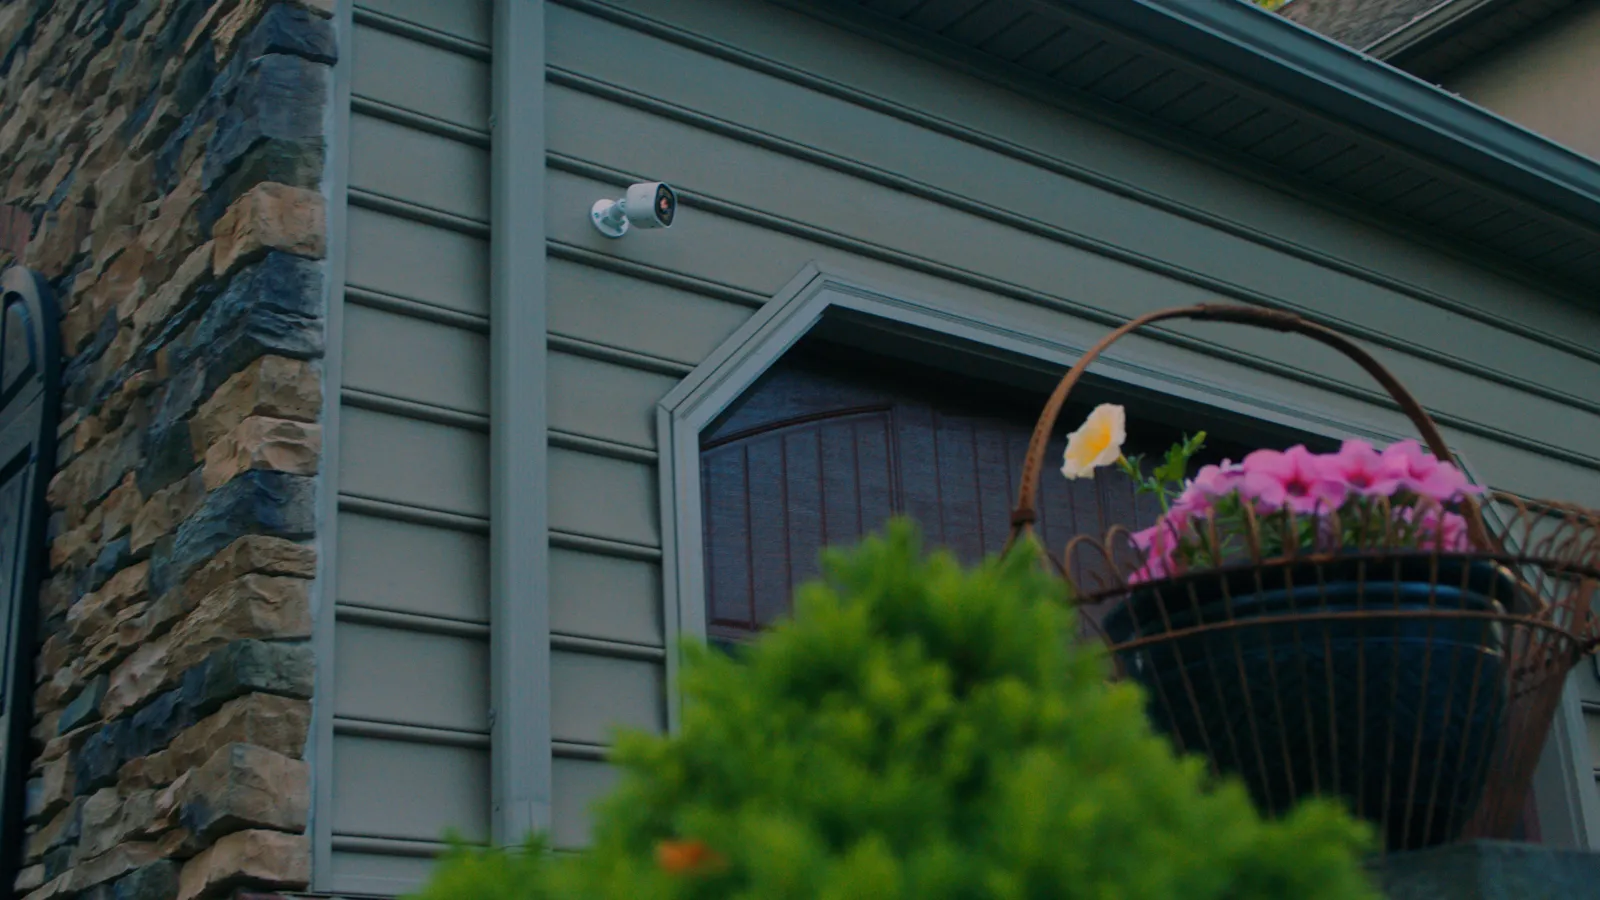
[211,181,328,275]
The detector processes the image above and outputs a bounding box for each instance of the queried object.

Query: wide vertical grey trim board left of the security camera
[490,0,550,844]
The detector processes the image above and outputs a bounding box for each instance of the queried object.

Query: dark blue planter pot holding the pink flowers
[1104,556,1517,850]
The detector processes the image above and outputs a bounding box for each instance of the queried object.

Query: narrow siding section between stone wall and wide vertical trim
[328,0,491,894]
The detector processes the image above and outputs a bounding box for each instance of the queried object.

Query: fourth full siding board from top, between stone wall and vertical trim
[344,303,490,415]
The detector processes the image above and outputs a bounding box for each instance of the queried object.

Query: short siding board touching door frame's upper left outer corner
[547,352,678,447]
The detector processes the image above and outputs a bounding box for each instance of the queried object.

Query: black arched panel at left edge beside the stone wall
[0,266,61,889]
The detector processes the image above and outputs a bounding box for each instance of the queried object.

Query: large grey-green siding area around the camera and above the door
[546,0,1600,846]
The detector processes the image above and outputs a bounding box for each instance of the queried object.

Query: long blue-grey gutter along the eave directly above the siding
[1034,0,1600,235]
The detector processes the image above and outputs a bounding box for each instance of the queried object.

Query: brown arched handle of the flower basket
[1010,303,1493,549]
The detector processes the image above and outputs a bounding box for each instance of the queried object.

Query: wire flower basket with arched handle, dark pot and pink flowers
[1013,304,1600,850]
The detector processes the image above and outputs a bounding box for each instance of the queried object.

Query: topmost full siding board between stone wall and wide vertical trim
[350,26,490,131]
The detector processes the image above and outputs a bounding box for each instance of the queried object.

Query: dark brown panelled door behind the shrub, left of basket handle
[701,347,1190,639]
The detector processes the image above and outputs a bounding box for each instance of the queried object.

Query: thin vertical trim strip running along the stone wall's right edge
[306,0,355,889]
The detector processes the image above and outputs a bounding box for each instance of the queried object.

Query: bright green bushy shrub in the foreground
[409,522,1376,900]
